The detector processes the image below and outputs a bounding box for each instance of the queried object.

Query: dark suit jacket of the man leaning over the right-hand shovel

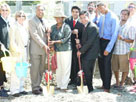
[80,22,99,60]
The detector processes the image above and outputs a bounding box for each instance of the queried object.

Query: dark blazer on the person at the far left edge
[0,16,9,49]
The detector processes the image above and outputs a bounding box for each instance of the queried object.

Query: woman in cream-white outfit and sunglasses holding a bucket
[9,11,29,97]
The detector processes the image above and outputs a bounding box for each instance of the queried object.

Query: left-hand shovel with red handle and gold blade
[45,32,54,95]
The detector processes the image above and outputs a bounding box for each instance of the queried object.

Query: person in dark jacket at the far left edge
[0,3,10,97]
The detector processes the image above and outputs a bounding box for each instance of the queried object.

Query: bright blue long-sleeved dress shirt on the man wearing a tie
[95,11,119,52]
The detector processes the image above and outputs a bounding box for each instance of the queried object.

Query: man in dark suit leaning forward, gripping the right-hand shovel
[77,11,99,92]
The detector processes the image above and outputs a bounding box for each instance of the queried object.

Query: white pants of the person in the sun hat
[56,51,72,89]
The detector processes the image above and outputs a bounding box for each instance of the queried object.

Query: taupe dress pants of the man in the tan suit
[30,54,46,91]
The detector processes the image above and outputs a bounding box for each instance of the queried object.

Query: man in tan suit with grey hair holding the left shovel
[29,4,49,95]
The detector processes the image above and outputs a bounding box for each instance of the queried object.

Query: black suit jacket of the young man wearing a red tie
[65,17,84,50]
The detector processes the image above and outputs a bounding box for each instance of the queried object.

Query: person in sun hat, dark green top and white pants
[50,10,72,92]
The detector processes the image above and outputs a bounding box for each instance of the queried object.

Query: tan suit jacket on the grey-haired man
[29,16,47,55]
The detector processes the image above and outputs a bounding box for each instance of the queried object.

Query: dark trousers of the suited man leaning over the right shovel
[82,59,96,92]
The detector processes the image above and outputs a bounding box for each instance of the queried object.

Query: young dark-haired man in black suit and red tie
[65,6,83,85]
